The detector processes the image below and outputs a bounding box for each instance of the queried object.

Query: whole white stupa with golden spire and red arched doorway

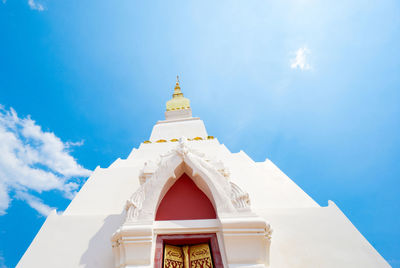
[17,77,390,268]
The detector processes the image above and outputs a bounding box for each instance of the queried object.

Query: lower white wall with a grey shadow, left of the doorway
[17,211,124,268]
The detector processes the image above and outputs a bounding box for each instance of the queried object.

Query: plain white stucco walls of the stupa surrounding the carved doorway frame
[17,110,390,268]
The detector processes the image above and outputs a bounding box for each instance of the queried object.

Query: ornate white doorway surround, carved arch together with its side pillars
[111,138,272,268]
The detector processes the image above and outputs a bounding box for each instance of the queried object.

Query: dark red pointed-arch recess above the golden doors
[156,173,217,221]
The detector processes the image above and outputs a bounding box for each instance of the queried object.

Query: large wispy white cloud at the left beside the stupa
[0,106,91,215]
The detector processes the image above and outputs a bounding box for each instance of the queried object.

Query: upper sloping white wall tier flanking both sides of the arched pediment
[65,140,318,215]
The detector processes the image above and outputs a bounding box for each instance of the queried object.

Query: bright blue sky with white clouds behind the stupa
[0,0,400,267]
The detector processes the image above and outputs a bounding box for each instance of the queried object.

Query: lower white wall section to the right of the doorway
[257,201,390,268]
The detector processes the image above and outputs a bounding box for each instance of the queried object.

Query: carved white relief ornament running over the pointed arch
[125,137,250,221]
